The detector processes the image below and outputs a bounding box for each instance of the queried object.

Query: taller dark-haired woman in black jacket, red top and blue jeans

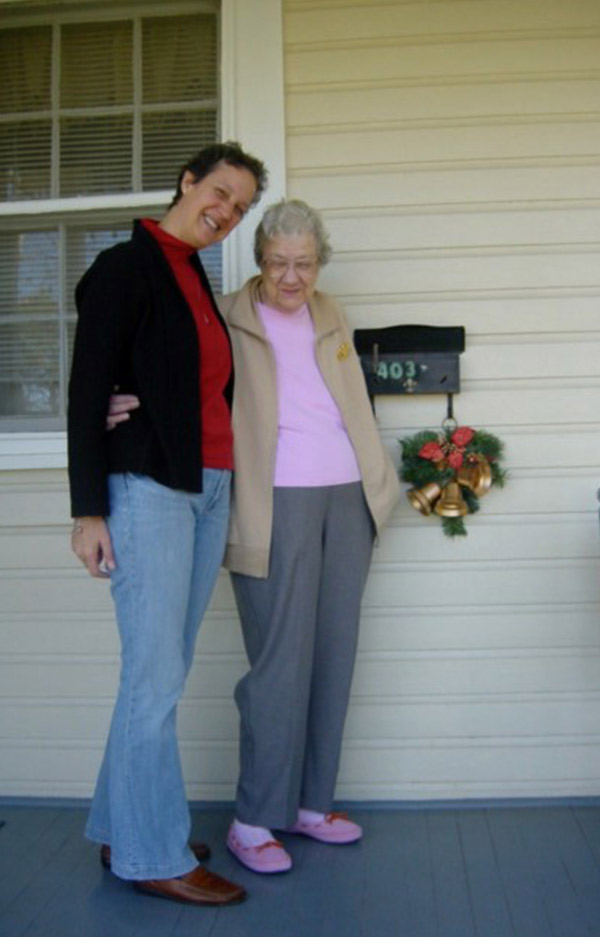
[69,143,266,905]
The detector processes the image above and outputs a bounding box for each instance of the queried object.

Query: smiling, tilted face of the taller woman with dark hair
[161,163,256,250]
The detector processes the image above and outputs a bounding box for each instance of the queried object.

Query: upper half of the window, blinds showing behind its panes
[0,4,218,201]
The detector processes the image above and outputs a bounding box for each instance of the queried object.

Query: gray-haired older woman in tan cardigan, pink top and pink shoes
[221,200,398,872]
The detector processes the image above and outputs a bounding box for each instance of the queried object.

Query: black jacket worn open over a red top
[68,222,233,517]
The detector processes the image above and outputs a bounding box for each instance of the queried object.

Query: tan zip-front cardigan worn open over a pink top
[219,277,399,579]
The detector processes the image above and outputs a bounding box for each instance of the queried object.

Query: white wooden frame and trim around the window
[0,0,285,471]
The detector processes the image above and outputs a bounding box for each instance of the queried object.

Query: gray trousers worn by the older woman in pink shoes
[231,482,374,829]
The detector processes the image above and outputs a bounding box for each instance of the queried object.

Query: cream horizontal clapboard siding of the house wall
[0,0,600,800]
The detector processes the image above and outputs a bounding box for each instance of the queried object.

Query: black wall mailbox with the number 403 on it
[354,325,465,397]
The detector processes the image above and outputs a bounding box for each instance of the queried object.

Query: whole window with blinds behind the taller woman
[0,2,221,430]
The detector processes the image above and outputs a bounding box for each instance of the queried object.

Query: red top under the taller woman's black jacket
[142,218,233,469]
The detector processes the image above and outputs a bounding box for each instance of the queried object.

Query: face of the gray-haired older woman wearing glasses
[260,234,319,312]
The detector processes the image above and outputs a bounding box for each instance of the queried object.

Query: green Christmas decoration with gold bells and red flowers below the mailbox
[399,420,506,537]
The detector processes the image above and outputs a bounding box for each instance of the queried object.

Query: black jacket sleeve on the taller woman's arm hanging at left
[67,245,143,517]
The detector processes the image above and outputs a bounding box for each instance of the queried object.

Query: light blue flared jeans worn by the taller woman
[86,469,231,880]
